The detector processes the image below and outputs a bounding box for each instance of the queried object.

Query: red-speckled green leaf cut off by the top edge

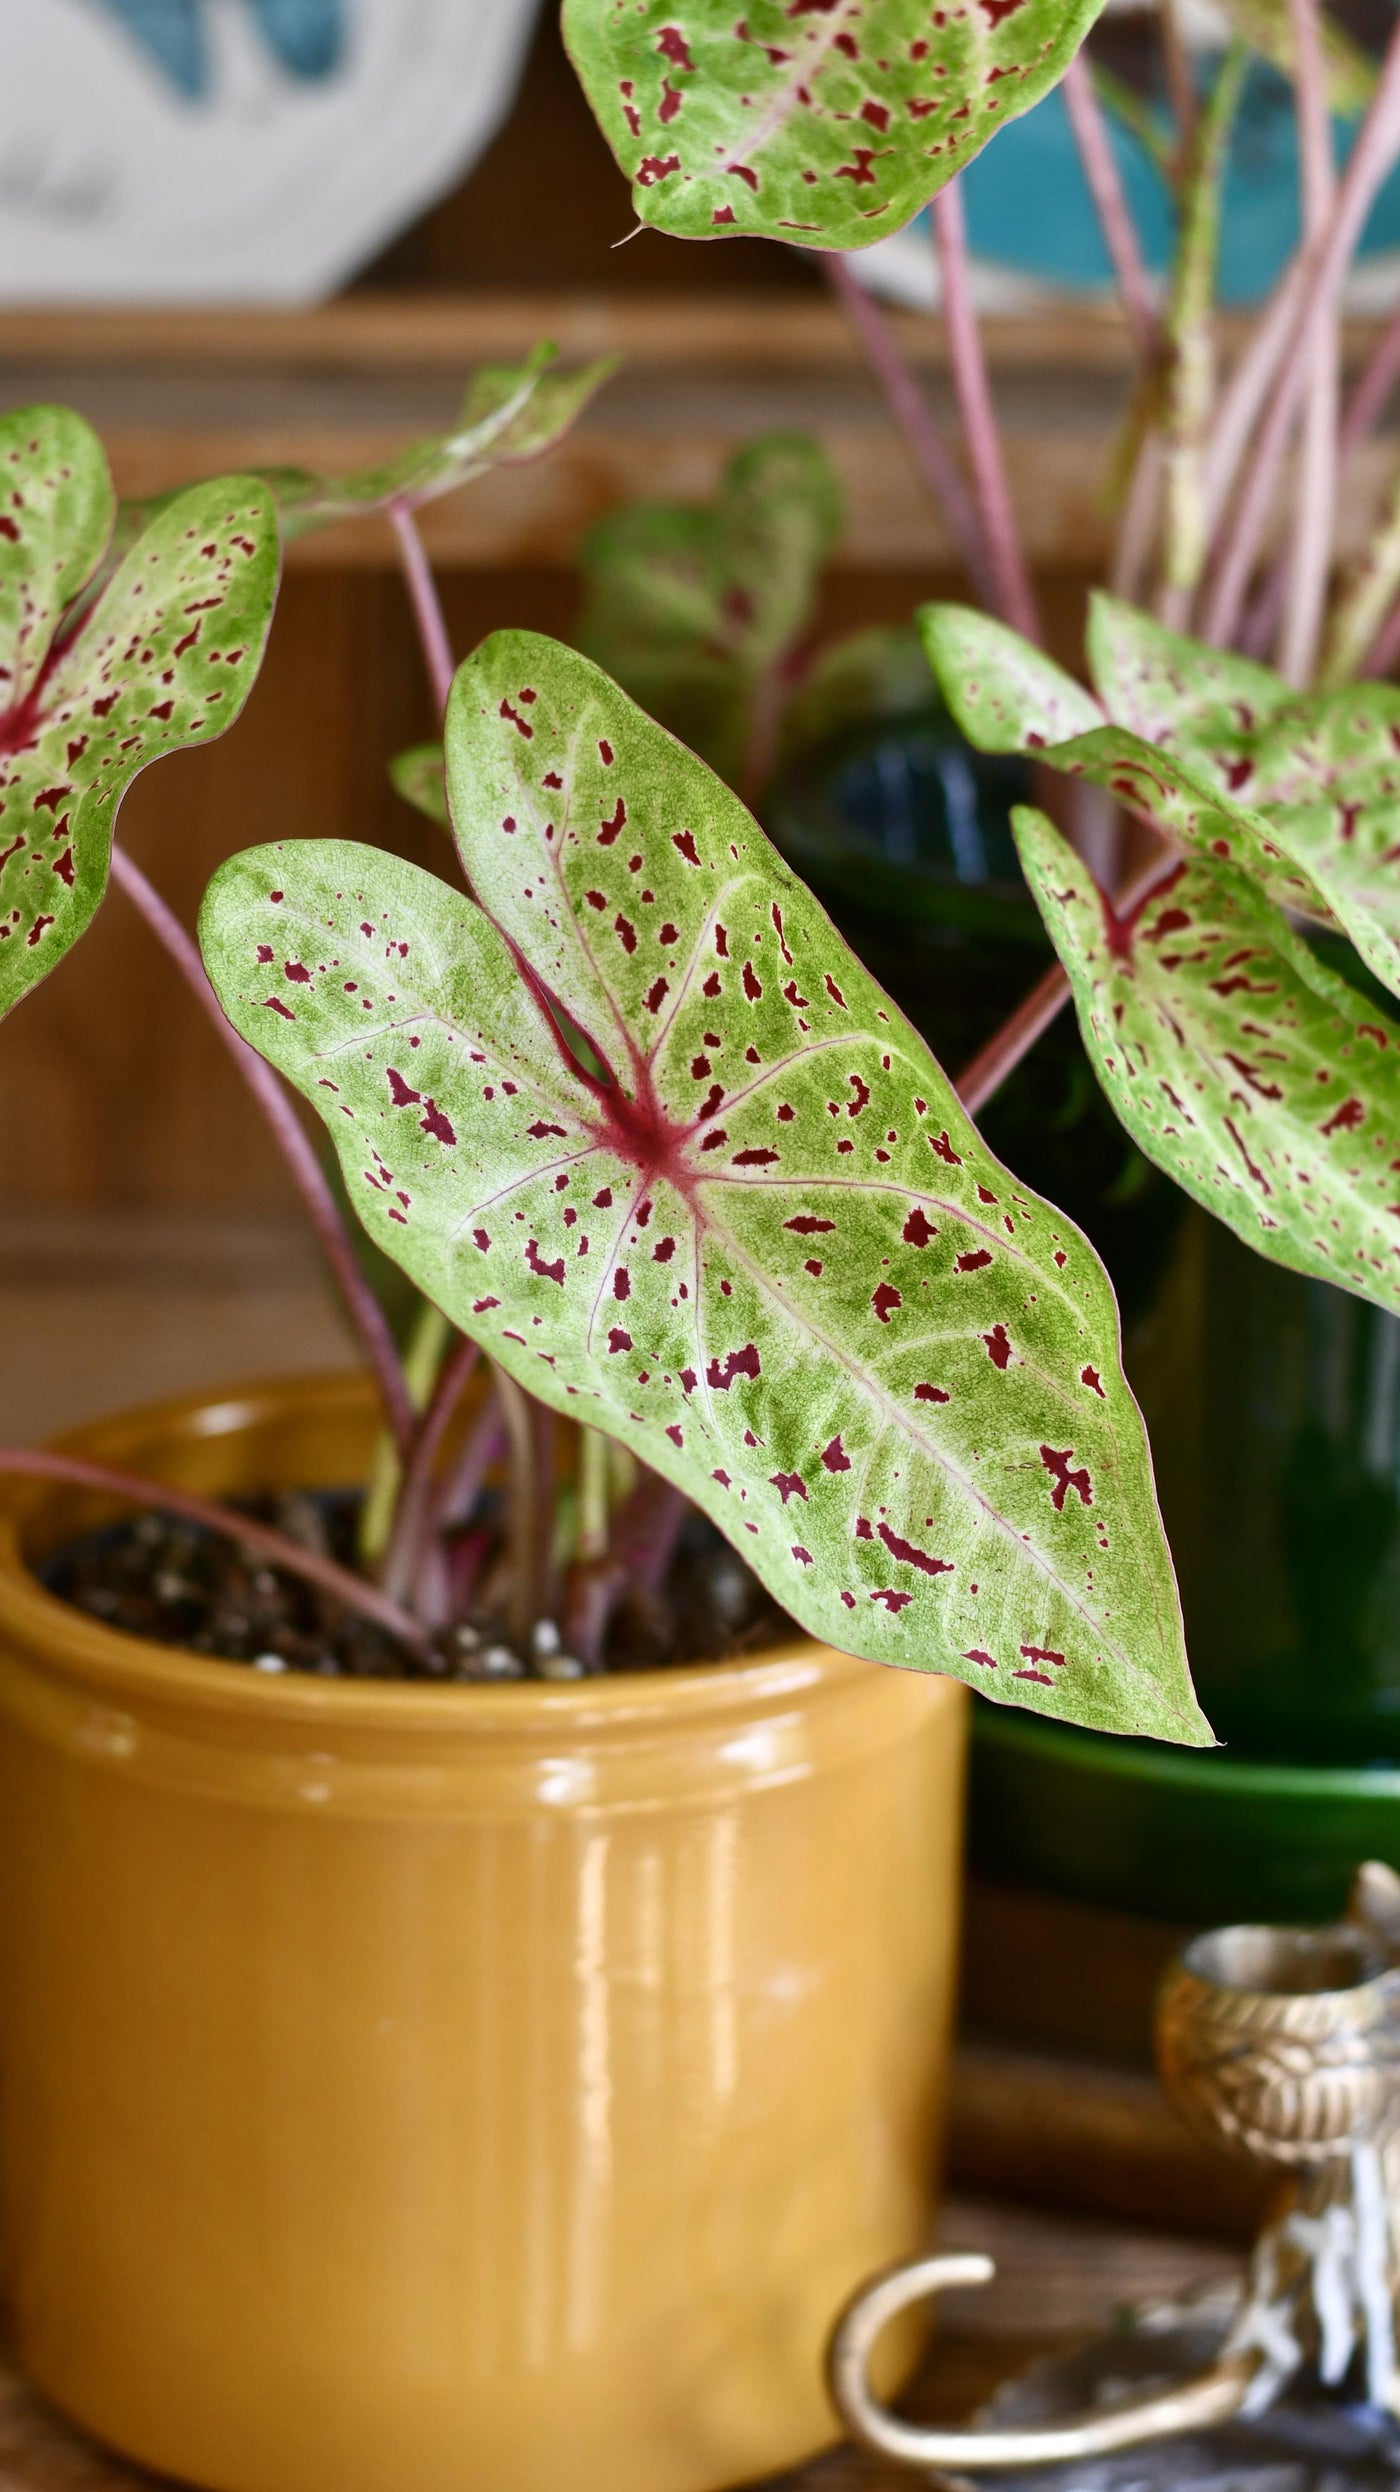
[563,0,1101,252]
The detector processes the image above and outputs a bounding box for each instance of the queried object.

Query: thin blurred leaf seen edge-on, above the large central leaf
[267,346,618,538]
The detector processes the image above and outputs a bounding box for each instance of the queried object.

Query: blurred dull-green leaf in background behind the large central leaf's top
[578,434,842,785]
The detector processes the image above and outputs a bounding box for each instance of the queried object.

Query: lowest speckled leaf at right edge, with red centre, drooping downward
[1014,807,1400,1311]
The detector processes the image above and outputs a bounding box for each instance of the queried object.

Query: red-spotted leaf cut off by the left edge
[0,406,277,1014]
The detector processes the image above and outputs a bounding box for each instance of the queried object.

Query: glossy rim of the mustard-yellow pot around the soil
[0,1376,874,1747]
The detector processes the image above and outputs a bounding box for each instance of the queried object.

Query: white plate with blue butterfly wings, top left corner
[0,0,538,304]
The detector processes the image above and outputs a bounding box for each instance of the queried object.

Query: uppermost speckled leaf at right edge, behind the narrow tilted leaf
[1089,598,1400,992]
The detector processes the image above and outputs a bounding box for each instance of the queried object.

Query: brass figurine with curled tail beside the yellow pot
[830,1862,1400,2492]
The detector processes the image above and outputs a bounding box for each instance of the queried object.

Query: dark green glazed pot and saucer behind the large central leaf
[772,710,1400,1921]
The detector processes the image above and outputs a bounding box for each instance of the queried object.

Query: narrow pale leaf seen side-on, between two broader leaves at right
[919,606,1333,925]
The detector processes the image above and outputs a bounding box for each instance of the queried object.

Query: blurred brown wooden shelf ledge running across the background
[0,294,1390,576]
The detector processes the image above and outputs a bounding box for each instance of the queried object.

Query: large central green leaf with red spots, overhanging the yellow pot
[202,633,1208,1742]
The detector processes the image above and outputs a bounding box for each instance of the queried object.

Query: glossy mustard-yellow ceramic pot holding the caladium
[0,1381,964,2492]
